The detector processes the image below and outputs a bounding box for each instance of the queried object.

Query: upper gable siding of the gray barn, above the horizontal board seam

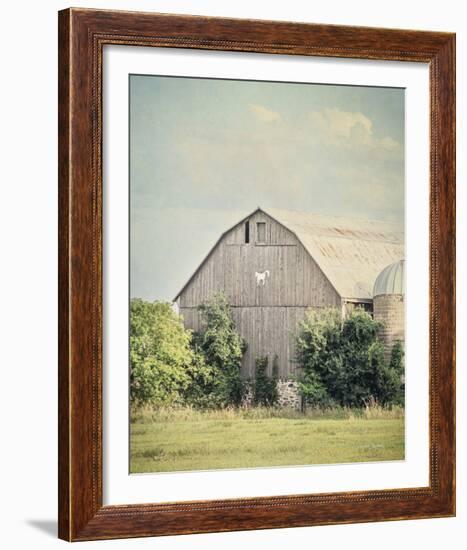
[179,214,341,308]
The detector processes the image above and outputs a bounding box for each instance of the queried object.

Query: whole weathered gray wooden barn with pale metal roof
[175,208,404,388]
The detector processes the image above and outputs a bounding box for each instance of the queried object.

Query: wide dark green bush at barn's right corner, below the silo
[297,308,403,407]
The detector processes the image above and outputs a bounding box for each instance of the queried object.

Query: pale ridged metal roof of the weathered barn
[261,208,404,300]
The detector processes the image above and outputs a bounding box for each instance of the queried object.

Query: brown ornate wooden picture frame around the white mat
[59,9,455,541]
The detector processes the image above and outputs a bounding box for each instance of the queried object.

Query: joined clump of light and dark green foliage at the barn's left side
[130,294,245,408]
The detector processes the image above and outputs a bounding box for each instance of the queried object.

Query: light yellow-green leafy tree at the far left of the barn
[130,299,213,406]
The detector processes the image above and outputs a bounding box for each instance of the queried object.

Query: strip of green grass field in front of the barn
[130,409,404,473]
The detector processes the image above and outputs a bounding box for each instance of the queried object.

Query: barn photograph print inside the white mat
[129,74,405,474]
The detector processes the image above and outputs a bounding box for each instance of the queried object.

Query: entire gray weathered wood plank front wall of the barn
[178,212,341,378]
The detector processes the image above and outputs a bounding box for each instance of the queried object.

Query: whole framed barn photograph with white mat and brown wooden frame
[59,8,455,541]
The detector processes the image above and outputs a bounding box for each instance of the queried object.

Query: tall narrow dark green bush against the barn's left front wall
[195,292,246,407]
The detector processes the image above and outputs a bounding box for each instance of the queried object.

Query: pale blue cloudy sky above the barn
[130,75,405,301]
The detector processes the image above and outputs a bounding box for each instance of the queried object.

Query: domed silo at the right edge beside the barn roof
[373,260,405,358]
